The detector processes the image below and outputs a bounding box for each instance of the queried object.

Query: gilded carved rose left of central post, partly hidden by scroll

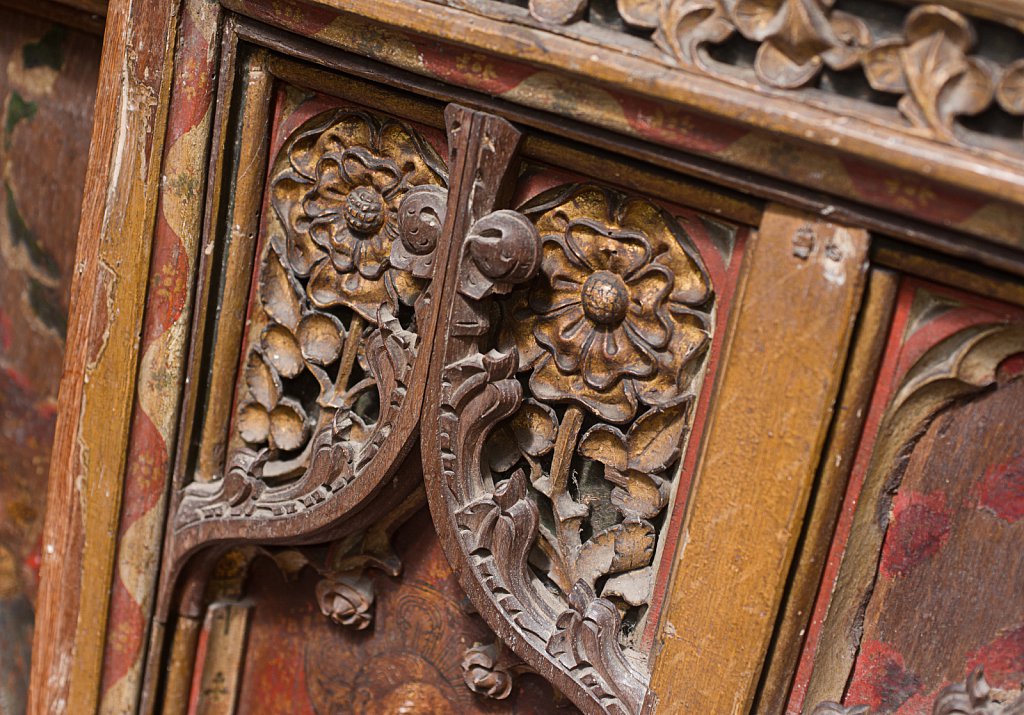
[272,111,445,323]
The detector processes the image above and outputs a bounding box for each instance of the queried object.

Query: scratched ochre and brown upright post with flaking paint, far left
[29,0,176,713]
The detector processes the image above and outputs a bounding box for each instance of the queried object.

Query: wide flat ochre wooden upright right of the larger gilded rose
[647,201,868,713]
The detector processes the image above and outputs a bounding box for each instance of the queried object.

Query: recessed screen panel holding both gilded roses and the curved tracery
[144,34,751,713]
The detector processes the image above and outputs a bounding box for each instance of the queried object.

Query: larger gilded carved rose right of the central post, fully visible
[507,187,711,423]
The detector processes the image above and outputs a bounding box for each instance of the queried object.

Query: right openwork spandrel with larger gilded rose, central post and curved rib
[423,109,714,713]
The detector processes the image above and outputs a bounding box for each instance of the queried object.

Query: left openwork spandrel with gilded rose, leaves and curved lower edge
[178,110,447,525]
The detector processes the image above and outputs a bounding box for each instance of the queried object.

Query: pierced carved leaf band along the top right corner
[475,0,1024,149]
